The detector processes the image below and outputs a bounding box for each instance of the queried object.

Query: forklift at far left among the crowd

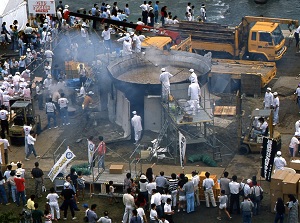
[9,101,41,145]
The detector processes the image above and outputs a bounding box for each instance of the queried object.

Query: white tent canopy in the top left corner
[0,0,27,30]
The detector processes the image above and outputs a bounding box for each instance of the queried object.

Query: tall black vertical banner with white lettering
[261,138,277,182]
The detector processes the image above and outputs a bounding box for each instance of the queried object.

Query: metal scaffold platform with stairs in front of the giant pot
[158,83,230,163]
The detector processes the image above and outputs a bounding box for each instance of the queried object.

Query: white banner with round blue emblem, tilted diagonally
[48,147,76,182]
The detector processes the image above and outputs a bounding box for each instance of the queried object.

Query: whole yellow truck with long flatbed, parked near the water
[166,16,298,61]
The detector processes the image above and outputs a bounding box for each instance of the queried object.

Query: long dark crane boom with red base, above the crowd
[67,11,181,44]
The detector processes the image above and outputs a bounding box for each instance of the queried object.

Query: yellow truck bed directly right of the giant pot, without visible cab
[208,59,277,96]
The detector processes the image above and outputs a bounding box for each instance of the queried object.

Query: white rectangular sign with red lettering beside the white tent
[28,0,56,14]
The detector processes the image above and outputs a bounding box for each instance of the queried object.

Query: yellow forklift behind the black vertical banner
[240,109,281,155]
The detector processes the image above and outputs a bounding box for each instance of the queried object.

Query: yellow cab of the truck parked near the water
[248,22,287,61]
